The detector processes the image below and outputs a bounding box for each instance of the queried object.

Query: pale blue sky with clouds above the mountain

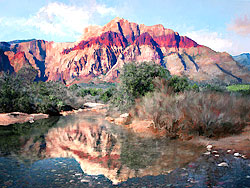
[0,0,250,55]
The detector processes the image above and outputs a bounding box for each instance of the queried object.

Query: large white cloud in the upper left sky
[0,0,116,39]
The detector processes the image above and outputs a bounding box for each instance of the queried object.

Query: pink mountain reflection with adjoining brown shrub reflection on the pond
[44,113,203,184]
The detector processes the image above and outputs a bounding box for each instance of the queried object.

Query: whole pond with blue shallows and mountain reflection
[0,112,250,187]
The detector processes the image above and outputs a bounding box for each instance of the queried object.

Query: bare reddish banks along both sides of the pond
[0,103,250,158]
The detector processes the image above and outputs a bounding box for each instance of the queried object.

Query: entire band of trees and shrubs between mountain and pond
[0,62,250,139]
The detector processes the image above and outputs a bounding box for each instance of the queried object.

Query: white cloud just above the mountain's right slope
[185,30,233,52]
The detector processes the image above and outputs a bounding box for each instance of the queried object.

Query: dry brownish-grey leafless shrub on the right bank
[133,78,250,138]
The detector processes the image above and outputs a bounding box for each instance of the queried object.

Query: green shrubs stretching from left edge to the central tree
[0,67,115,115]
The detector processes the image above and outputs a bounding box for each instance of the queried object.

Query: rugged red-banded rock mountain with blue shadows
[0,18,250,83]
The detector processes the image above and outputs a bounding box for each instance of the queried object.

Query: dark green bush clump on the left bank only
[0,68,83,115]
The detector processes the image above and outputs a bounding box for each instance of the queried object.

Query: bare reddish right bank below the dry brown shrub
[106,113,250,158]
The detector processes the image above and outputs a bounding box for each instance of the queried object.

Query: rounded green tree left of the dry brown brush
[112,62,170,111]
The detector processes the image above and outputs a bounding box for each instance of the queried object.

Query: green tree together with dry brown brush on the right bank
[112,63,250,139]
